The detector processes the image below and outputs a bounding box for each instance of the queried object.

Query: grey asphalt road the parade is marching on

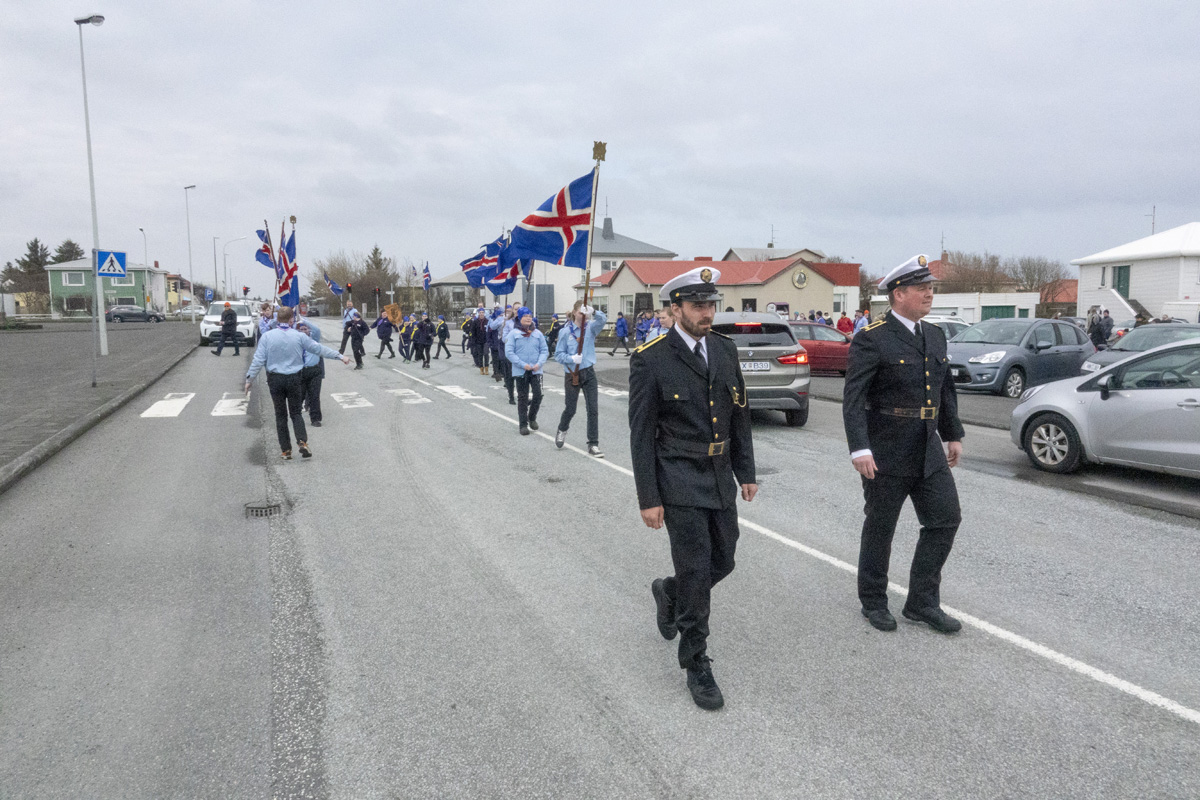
[0,323,1200,798]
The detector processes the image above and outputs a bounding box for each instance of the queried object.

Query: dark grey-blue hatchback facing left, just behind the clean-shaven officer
[947,319,1096,398]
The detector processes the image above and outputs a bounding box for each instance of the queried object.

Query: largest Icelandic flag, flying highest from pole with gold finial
[508,173,594,270]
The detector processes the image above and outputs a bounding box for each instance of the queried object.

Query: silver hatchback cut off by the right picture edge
[1009,338,1200,477]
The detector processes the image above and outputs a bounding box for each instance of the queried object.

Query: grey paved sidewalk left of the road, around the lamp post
[0,323,200,492]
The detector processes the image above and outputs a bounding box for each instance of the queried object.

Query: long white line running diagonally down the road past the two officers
[472,403,1200,724]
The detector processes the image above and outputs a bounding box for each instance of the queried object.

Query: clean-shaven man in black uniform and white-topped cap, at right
[842,255,962,633]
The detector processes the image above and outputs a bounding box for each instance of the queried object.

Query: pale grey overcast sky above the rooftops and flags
[0,0,1200,293]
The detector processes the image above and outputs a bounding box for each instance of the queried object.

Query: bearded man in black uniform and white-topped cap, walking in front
[629,267,758,710]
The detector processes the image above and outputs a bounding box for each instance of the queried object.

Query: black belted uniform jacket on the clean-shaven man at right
[841,312,962,476]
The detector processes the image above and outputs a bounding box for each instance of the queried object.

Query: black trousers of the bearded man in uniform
[662,504,739,669]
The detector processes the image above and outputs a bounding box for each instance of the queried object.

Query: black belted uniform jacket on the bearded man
[629,329,757,509]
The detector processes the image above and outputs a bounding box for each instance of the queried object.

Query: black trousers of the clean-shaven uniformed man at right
[858,468,962,610]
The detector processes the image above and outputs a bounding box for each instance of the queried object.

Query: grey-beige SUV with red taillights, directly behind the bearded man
[713,312,809,427]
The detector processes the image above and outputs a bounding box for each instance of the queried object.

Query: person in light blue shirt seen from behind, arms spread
[246,306,350,461]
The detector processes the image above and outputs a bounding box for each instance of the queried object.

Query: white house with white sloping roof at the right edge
[1072,222,1200,319]
